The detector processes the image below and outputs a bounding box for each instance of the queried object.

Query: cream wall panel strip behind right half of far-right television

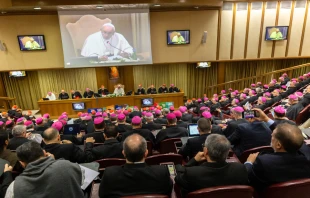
[274,2,291,57]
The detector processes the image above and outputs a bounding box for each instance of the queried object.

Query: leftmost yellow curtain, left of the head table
[1,71,41,110]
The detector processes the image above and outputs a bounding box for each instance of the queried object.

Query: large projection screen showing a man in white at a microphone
[58,9,152,68]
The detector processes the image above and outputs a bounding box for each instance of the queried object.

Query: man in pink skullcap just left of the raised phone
[223,107,248,137]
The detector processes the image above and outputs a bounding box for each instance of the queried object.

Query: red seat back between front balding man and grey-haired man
[145,153,183,165]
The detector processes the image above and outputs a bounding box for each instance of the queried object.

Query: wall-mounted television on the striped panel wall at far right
[265,26,288,41]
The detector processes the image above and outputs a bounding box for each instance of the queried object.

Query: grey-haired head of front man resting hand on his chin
[205,134,231,162]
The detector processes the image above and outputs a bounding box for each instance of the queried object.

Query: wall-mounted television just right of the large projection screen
[167,30,190,45]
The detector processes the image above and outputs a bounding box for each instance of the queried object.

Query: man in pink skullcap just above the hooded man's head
[7,125,30,150]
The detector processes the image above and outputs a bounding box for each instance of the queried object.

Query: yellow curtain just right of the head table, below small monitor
[187,63,218,98]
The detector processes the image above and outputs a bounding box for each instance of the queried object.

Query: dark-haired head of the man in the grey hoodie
[16,141,44,164]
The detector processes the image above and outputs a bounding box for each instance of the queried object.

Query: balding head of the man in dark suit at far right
[273,123,304,153]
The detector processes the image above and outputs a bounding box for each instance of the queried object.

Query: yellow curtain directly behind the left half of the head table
[38,68,97,97]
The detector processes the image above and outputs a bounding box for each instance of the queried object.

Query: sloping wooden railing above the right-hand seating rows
[205,63,310,95]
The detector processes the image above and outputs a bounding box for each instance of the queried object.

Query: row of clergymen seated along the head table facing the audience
[46,84,180,100]
